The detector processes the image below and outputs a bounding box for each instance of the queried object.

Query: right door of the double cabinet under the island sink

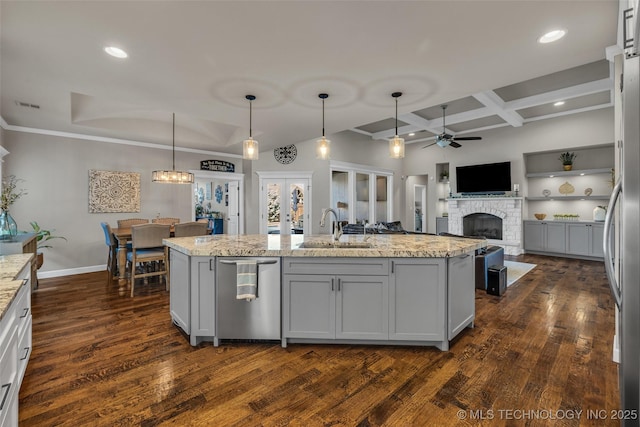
[336,276,389,340]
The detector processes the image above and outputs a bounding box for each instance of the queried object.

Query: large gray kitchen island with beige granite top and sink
[164,234,486,350]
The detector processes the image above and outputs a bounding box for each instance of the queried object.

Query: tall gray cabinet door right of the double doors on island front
[389,258,446,341]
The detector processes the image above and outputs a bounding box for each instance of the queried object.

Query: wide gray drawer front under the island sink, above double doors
[283,258,389,276]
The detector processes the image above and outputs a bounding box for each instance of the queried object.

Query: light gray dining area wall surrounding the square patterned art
[3,131,242,277]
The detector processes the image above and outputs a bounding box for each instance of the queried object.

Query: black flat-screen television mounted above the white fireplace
[456,162,511,194]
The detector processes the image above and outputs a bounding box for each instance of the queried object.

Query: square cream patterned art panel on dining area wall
[89,170,140,213]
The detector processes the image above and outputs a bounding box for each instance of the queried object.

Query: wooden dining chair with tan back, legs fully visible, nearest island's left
[127,224,171,297]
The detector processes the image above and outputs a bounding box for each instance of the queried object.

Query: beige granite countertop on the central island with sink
[163,234,487,258]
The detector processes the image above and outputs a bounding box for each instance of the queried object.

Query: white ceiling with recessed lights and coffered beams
[0,0,618,154]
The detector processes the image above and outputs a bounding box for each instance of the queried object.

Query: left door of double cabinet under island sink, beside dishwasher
[282,274,337,339]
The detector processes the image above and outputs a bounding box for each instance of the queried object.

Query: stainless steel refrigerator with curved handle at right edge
[604,2,640,426]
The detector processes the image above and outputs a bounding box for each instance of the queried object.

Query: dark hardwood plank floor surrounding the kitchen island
[20,255,619,426]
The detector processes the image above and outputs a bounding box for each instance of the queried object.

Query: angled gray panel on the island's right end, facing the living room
[447,254,476,340]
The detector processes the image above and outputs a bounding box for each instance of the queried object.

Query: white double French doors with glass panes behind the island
[259,172,311,235]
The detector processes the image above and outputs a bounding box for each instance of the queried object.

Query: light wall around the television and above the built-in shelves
[404,108,614,233]
